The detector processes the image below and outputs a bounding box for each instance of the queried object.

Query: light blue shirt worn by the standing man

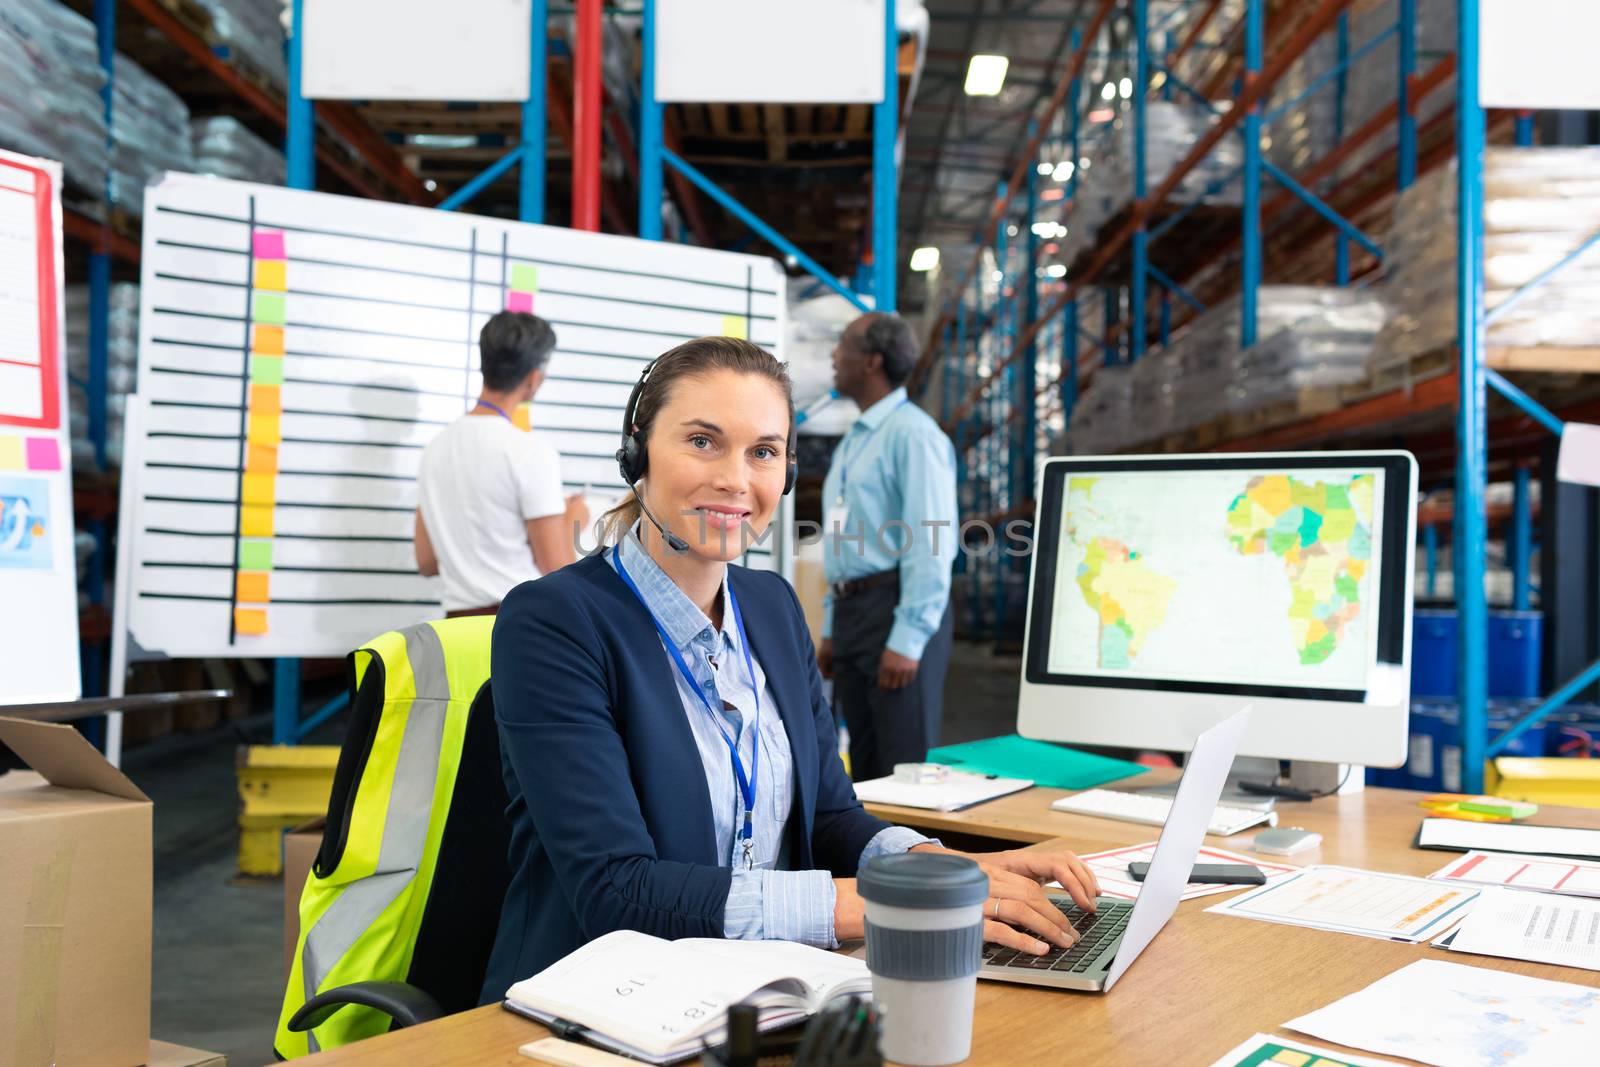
[822,386,960,659]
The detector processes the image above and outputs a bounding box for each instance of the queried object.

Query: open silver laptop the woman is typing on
[978,707,1250,992]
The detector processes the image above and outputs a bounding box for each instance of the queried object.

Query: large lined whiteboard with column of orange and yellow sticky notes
[128,174,789,657]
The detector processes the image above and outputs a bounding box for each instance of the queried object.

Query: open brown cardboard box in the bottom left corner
[0,718,150,1067]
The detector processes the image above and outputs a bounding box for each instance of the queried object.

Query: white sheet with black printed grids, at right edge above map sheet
[1450,888,1600,971]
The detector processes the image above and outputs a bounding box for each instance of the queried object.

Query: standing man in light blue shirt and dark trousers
[818,312,960,781]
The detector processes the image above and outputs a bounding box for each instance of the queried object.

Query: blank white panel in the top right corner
[1478,0,1600,110]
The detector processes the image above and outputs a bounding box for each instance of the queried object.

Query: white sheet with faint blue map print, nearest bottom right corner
[1283,960,1600,1067]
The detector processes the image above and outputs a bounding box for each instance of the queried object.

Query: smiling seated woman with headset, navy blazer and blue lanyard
[483,338,1098,1001]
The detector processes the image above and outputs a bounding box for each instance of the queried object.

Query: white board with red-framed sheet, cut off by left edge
[0,150,82,704]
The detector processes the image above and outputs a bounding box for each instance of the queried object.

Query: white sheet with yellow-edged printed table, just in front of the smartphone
[1208,867,1478,942]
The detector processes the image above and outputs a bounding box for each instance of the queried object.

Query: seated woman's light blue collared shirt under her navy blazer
[606,530,931,949]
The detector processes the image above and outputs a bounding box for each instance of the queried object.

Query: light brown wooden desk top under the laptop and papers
[288,790,1600,1067]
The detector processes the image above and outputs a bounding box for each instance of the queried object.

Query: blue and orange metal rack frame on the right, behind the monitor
[914,0,1600,792]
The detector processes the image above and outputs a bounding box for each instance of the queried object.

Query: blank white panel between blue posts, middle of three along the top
[656,0,883,104]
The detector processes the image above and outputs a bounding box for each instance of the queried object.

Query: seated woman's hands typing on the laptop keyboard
[914,845,1099,953]
